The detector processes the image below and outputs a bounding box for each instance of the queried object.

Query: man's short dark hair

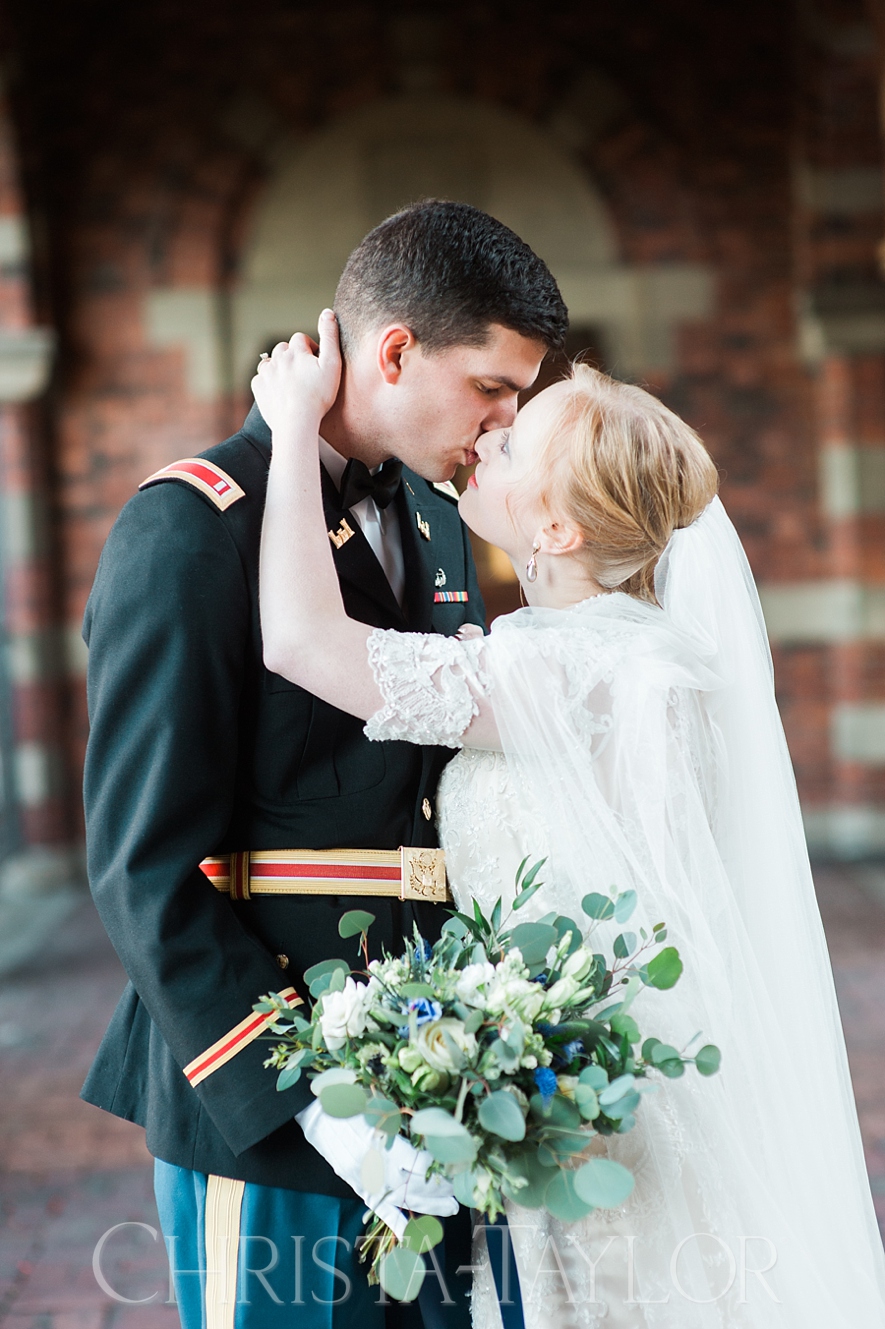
[335,198,569,356]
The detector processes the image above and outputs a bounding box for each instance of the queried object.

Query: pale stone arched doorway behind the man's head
[231,93,710,617]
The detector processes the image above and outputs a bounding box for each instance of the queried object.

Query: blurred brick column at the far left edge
[0,88,76,894]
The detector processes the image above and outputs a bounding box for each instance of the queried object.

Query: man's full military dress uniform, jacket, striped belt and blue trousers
[82,408,484,1329]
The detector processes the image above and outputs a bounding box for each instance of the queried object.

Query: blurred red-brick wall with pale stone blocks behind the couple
[3,0,885,851]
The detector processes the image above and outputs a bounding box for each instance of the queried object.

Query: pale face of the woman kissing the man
[458,383,565,562]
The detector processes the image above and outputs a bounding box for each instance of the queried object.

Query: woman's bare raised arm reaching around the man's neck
[252,310,500,747]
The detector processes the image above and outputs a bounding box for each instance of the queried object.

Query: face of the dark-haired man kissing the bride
[372,324,545,481]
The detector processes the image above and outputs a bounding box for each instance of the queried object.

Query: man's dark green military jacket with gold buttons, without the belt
[82,408,484,1196]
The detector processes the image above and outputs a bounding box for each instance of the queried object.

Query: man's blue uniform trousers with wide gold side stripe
[154,1159,472,1329]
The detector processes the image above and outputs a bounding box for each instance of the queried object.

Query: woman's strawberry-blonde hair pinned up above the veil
[534,364,719,603]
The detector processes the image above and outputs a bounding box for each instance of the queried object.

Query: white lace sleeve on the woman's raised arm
[364,627,489,747]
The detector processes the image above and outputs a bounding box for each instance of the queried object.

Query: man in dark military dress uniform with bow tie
[82,201,567,1329]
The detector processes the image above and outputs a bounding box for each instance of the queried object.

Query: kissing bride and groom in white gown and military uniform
[84,201,885,1329]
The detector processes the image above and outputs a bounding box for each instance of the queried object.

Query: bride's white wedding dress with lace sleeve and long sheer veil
[365,500,885,1329]
